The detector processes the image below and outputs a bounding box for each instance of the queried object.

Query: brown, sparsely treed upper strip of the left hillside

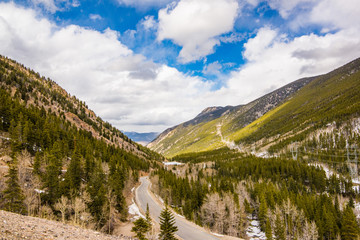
[0,56,161,161]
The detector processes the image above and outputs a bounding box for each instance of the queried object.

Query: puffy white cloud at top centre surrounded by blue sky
[158,0,239,63]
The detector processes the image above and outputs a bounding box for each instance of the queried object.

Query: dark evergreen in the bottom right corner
[341,205,359,240]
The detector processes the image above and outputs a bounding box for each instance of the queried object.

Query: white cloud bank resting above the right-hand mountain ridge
[222,27,360,104]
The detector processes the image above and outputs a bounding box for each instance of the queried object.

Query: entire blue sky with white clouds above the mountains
[0,0,360,132]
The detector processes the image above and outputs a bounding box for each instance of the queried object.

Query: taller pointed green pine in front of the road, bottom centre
[159,205,178,240]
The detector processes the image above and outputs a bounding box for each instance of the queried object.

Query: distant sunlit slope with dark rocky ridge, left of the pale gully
[148,75,314,157]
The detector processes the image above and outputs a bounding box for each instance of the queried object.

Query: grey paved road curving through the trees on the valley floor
[136,177,220,240]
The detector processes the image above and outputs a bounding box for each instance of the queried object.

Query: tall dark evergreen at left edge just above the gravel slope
[3,163,26,214]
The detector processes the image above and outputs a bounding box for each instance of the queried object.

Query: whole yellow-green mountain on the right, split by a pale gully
[148,59,360,157]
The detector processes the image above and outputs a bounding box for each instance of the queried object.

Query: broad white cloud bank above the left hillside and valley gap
[0,3,211,131]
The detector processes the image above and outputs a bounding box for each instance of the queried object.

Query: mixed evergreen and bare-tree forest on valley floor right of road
[152,148,360,239]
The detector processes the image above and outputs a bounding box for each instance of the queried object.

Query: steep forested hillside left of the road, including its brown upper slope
[0,57,162,233]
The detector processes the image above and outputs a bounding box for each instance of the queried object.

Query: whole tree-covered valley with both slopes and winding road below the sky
[0,55,360,240]
